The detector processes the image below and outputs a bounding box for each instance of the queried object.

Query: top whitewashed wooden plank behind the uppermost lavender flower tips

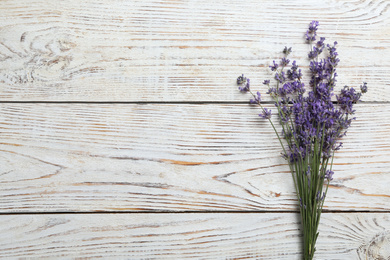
[0,0,390,101]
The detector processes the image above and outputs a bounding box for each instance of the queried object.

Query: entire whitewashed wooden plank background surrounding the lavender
[0,0,390,259]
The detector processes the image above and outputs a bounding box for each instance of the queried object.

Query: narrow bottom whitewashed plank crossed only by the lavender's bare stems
[0,213,390,260]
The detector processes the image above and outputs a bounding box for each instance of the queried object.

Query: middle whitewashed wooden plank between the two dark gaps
[0,104,390,212]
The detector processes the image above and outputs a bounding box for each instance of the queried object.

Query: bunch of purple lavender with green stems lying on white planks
[237,21,367,259]
